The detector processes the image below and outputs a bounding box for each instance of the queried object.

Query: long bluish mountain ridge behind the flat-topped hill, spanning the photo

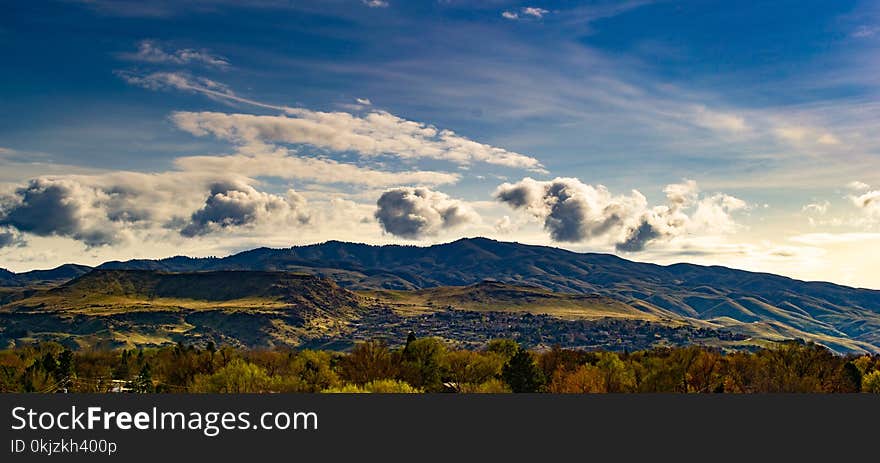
[0,238,880,352]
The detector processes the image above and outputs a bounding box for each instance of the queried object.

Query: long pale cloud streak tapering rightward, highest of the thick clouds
[172,108,543,170]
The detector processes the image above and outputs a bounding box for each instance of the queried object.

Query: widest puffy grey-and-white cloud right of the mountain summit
[495,178,746,252]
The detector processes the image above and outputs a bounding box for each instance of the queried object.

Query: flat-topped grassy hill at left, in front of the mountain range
[0,270,363,347]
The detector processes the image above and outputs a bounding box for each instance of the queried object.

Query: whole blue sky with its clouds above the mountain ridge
[0,0,880,288]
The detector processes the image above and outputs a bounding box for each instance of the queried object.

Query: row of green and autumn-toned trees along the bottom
[0,335,880,393]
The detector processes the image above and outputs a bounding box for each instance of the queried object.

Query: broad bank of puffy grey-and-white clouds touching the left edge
[0,171,309,247]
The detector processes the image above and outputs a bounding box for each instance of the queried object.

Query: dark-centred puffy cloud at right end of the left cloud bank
[180,182,309,237]
